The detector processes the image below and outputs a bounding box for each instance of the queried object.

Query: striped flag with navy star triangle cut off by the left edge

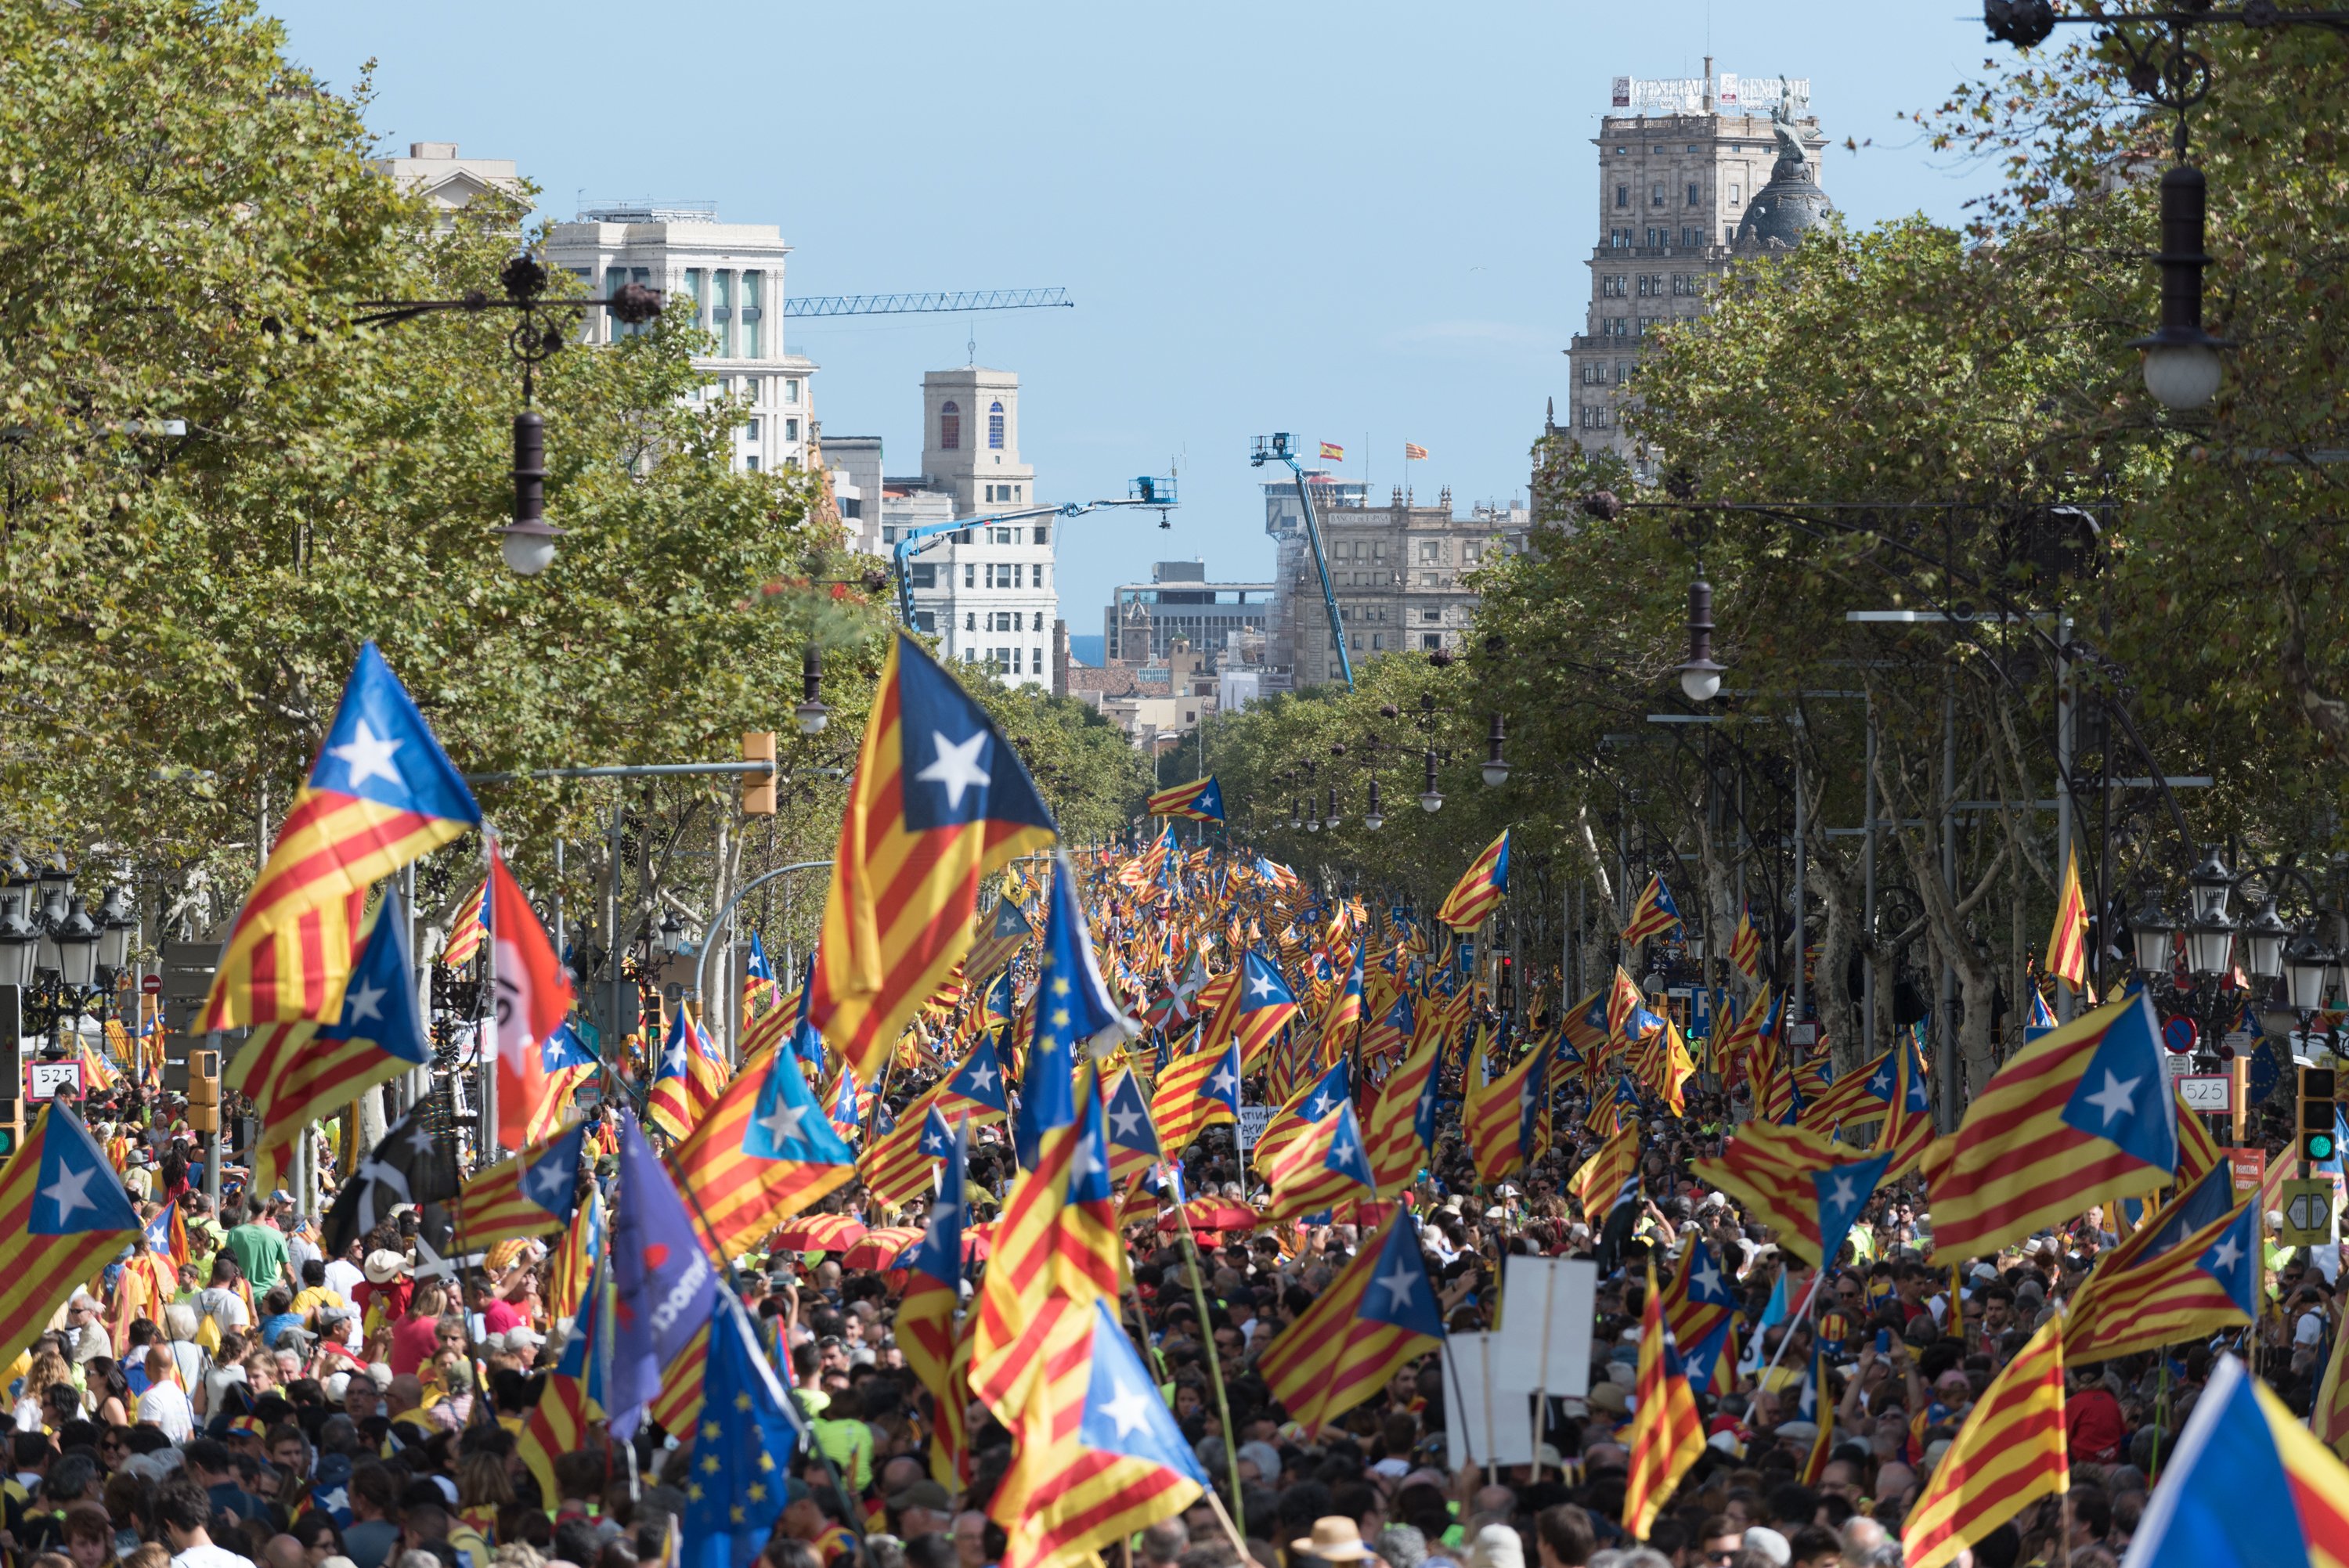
[0,1101,139,1364]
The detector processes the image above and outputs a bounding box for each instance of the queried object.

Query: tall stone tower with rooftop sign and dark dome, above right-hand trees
[1553,69,1832,463]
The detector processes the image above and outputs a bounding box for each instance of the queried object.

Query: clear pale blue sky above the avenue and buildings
[265,0,1992,634]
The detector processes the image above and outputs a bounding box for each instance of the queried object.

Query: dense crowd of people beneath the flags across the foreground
[0,1018,2337,1568]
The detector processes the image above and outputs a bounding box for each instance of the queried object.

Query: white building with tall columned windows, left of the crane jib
[545,207,815,472]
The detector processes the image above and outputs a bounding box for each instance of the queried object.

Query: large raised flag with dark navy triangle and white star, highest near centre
[810,632,1057,1080]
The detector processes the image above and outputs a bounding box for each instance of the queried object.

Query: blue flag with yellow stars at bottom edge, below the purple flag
[679,1291,806,1568]
